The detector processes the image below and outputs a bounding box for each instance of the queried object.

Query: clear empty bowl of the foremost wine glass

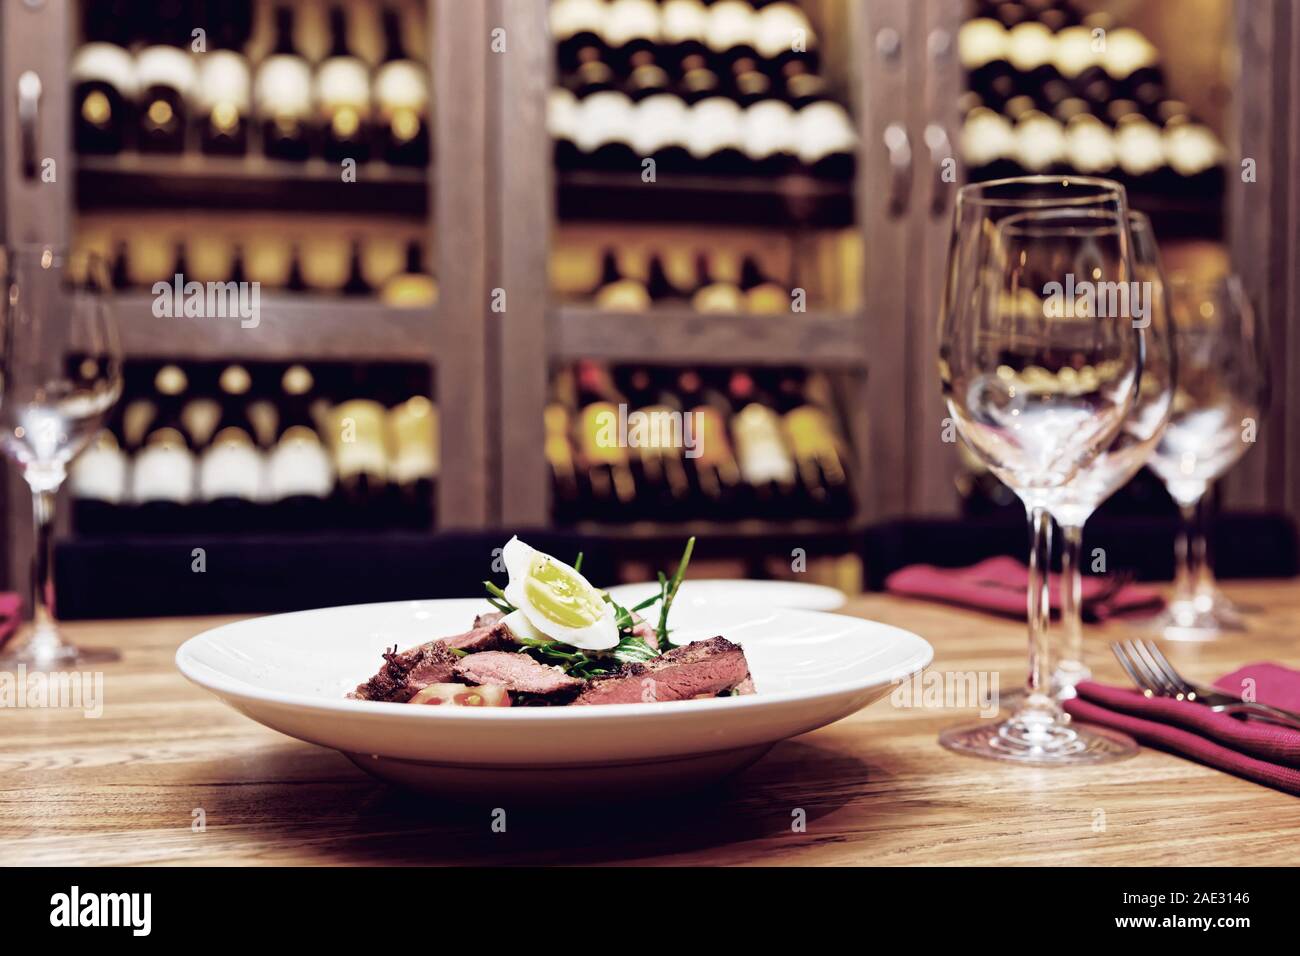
[940,187,1140,499]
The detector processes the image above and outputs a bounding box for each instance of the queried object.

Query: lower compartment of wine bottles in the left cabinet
[69,360,439,537]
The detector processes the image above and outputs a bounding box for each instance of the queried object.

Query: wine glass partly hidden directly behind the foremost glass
[1048,212,1177,698]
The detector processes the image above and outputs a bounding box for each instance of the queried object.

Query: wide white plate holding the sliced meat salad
[176,598,933,800]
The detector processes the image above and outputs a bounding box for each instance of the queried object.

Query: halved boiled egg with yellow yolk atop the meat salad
[502,537,619,650]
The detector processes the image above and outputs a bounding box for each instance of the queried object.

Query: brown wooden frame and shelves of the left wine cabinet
[0,0,498,591]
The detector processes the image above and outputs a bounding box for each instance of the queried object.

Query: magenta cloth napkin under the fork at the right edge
[1065,663,1300,796]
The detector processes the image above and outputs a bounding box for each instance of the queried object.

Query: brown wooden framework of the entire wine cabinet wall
[0,0,1300,598]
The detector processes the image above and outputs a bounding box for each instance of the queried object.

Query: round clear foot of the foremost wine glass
[939,717,1138,766]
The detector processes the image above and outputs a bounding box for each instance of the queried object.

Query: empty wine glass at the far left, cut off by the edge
[0,245,122,670]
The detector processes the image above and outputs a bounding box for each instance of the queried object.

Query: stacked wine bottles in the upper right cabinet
[958,0,1226,239]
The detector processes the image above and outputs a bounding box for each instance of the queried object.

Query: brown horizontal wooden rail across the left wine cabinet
[113,293,438,362]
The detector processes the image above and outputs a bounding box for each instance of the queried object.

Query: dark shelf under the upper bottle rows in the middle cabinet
[555,170,854,228]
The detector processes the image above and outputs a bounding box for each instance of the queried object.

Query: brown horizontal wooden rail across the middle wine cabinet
[547,306,866,368]
